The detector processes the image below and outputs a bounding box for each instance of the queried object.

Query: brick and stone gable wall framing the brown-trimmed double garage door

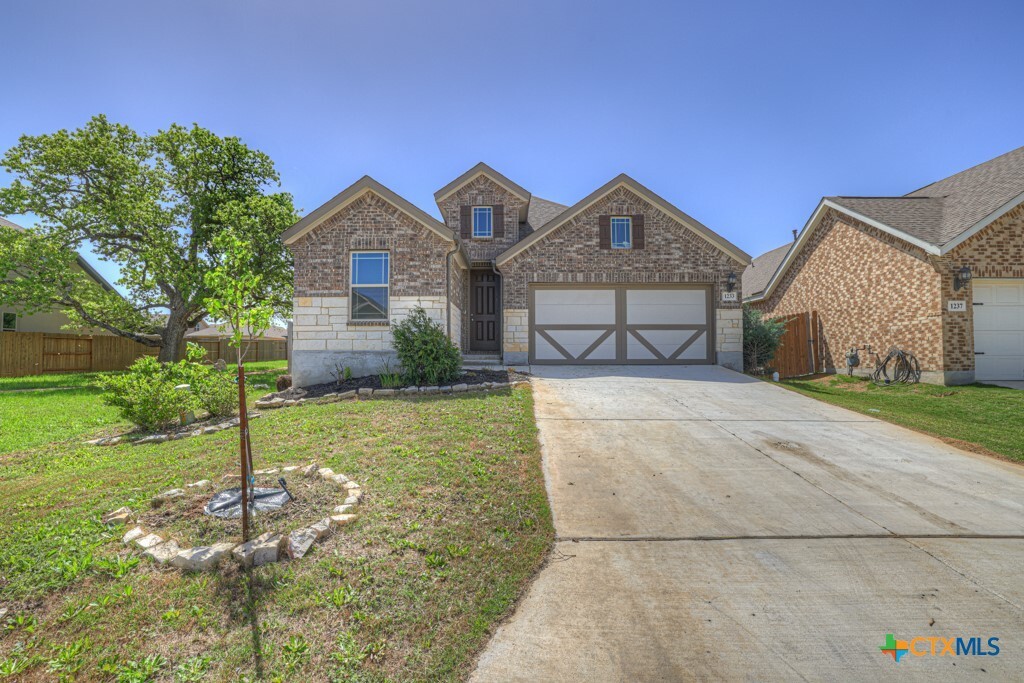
[499,186,743,369]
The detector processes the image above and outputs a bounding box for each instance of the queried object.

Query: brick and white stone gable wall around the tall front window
[290,193,461,387]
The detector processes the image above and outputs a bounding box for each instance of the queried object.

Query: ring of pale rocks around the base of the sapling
[101,464,362,571]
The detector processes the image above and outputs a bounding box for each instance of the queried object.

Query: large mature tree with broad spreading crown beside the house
[0,116,297,361]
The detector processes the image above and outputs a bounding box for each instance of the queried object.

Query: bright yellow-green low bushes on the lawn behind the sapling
[99,344,238,429]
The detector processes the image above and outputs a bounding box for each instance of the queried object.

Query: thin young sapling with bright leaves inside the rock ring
[203,198,283,541]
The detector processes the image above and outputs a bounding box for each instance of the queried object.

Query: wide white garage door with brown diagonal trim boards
[529,285,715,365]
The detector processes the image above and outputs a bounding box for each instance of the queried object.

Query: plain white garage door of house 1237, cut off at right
[972,280,1024,380]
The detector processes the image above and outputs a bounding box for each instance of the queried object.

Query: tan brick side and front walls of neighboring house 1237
[754,206,1024,383]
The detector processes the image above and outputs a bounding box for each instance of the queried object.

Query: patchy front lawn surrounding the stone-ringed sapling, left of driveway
[0,387,553,681]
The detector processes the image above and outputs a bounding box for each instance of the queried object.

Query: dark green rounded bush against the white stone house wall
[391,307,462,385]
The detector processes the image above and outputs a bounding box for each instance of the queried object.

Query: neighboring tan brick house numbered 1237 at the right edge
[743,147,1024,384]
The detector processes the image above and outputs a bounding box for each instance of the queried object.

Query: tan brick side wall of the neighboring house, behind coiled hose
[754,210,944,373]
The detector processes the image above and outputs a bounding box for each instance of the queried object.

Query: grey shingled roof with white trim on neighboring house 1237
[753,147,1024,299]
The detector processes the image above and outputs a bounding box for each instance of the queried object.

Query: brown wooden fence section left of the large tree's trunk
[0,332,160,377]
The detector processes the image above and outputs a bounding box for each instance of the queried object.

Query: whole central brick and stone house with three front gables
[283,163,750,386]
